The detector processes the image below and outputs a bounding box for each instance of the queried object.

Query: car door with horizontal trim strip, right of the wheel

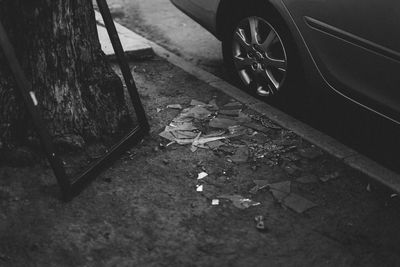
[283,0,400,116]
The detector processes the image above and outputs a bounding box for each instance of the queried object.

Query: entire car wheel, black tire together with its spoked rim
[222,7,304,103]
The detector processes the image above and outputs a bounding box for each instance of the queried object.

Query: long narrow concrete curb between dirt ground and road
[105,19,400,193]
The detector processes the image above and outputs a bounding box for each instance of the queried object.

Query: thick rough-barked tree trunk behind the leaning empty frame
[0,0,129,157]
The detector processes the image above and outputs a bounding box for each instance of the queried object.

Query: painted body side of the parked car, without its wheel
[171,0,400,123]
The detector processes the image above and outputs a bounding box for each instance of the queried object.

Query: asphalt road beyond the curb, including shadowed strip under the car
[108,0,400,172]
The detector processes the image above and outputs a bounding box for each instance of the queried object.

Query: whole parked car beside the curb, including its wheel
[171,0,400,123]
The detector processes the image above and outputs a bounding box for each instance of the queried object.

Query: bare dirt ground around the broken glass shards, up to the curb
[0,58,400,266]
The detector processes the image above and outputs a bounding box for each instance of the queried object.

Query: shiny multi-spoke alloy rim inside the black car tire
[232,16,287,97]
